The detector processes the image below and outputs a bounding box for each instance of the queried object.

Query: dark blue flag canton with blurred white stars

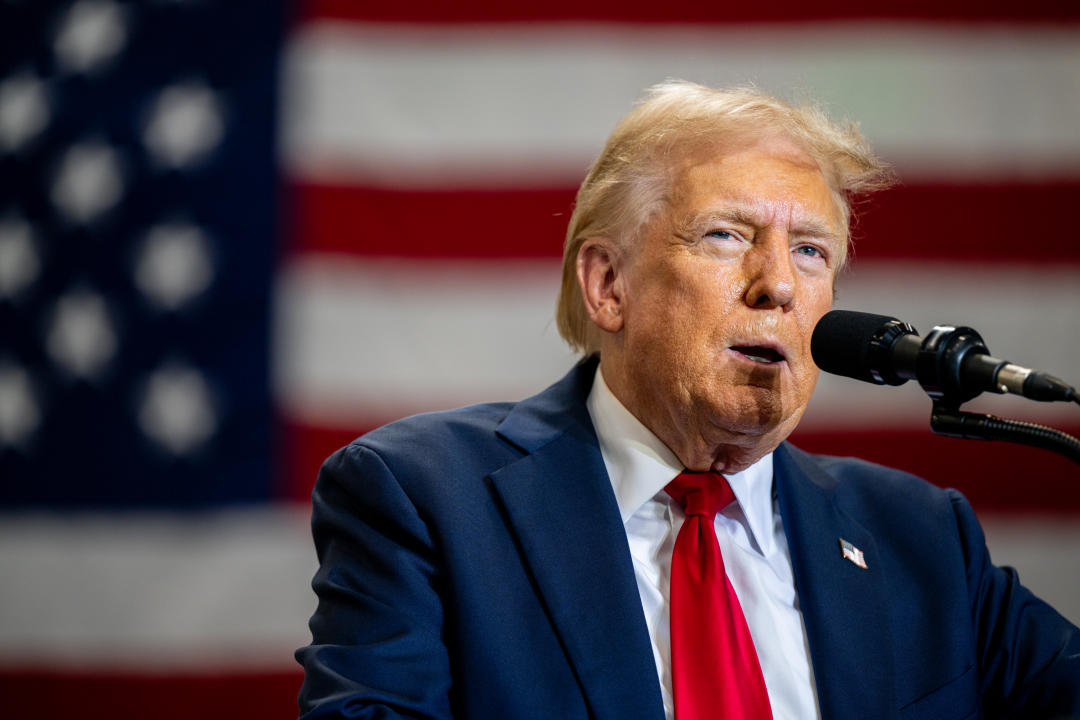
[0,1,283,508]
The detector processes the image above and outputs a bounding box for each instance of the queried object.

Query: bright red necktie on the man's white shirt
[665,472,772,720]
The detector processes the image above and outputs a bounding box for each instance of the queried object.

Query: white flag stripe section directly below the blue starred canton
[0,505,316,671]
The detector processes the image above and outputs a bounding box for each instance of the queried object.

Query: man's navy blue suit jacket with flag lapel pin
[297,362,1080,720]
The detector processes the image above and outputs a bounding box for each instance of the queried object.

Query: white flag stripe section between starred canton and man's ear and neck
[274,254,575,426]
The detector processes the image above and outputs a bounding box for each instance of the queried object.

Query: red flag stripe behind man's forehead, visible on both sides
[292,179,1080,263]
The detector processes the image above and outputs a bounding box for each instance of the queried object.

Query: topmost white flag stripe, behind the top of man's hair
[283,23,1080,188]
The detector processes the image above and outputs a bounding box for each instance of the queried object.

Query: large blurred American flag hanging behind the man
[0,0,1080,719]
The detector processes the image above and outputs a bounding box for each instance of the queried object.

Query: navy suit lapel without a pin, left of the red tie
[491,364,664,720]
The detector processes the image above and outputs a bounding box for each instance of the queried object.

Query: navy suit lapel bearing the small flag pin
[774,445,896,718]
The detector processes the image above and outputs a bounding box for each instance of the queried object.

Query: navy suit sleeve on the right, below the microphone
[949,490,1080,718]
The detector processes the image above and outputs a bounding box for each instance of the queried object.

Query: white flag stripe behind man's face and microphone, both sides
[275,254,1080,429]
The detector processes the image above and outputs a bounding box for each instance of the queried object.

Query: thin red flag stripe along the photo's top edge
[300,0,1080,23]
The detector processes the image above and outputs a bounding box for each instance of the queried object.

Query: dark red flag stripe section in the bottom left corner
[0,667,303,720]
